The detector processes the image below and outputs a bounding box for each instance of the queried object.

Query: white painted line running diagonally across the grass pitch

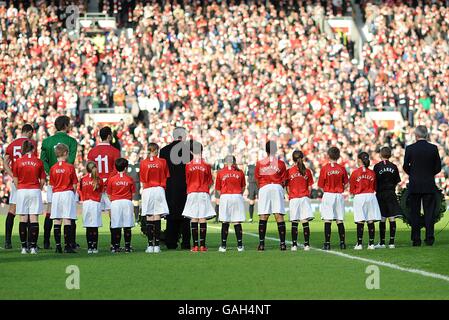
[210,226,449,282]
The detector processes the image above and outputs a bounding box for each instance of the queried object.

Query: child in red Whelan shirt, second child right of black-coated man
[215,155,246,252]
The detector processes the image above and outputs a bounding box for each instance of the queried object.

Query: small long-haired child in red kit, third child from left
[78,161,104,254]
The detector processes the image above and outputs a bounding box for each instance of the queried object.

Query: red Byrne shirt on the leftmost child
[13,153,45,189]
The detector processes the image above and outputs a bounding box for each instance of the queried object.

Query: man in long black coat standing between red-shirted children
[160,127,192,250]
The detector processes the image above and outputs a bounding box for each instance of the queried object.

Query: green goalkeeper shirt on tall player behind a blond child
[41,132,78,174]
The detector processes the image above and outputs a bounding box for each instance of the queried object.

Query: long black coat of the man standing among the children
[159,141,192,215]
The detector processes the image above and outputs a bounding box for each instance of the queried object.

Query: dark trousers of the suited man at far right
[409,193,437,242]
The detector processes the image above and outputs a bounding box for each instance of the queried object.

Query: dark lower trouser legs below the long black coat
[165,214,190,249]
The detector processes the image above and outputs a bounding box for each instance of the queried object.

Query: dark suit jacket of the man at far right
[403,140,441,193]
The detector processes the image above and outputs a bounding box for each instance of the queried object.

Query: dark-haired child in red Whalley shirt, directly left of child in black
[349,152,381,250]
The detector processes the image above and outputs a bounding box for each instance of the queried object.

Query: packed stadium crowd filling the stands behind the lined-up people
[0,0,449,201]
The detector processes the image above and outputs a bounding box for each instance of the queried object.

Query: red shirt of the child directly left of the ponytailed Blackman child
[254,157,287,188]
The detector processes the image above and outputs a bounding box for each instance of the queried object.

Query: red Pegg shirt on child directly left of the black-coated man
[140,157,170,189]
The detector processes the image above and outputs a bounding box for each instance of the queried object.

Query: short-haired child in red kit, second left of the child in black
[318,147,349,250]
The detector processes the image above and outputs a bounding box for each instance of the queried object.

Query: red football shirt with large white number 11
[87,142,121,179]
